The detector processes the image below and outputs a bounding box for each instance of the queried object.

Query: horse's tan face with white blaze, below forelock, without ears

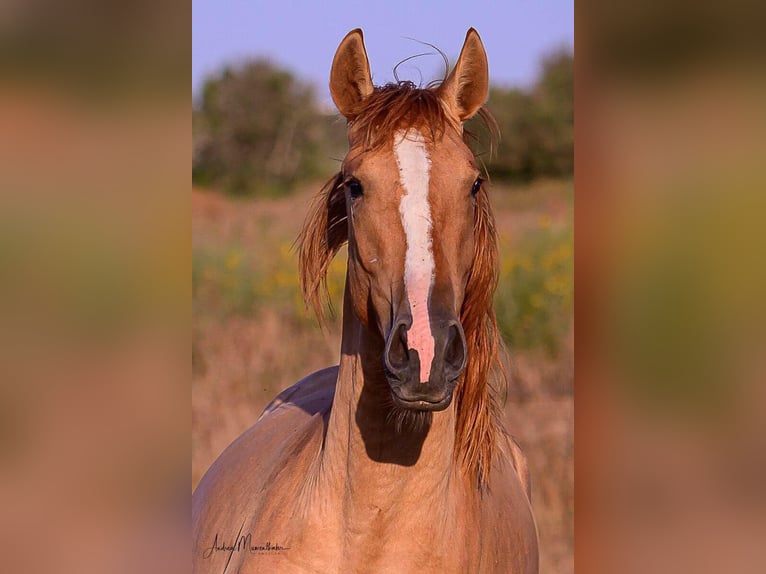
[344,128,478,410]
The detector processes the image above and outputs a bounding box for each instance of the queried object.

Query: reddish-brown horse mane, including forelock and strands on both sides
[298,82,506,487]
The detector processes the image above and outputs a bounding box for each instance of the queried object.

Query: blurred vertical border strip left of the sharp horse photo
[0,0,191,574]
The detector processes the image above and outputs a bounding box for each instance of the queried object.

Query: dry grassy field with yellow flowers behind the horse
[192,181,574,574]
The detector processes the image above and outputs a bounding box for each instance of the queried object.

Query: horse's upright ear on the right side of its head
[440,28,489,122]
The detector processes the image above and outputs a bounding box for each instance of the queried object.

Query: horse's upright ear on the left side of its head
[330,28,373,120]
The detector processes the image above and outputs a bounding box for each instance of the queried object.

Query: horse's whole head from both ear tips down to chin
[330,32,487,410]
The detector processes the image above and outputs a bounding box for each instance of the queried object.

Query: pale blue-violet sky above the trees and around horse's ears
[192,0,574,103]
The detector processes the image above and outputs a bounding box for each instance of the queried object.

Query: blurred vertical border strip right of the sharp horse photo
[575,0,766,574]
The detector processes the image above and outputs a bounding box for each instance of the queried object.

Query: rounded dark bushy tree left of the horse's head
[192,59,343,195]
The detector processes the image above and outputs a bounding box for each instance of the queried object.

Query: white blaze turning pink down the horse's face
[394,129,435,383]
